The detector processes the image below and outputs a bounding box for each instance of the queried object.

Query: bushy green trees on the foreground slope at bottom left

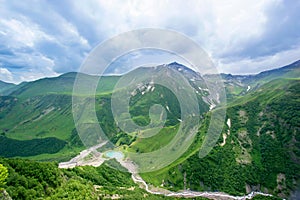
[0,158,206,200]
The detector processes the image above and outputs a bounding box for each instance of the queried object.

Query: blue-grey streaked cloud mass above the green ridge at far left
[0,2,91,82]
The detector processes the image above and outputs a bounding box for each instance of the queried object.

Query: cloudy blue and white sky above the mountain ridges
[0,0,300,83]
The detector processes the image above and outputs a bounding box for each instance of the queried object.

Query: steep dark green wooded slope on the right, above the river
[142,79,300,196]
